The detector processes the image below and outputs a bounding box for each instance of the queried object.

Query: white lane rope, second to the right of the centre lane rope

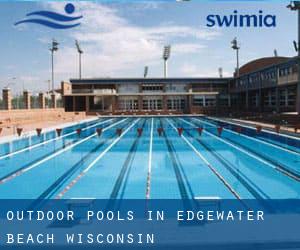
[184,118,300,181]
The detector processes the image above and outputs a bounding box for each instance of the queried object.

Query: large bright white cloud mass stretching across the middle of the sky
[41,2,219,79]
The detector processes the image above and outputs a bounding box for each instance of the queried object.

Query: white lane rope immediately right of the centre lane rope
[167,119,241,200]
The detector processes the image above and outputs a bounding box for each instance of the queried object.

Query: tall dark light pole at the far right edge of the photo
[287,1,300,115]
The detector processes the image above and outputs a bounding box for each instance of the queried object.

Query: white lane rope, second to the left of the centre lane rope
[0,118,128,184]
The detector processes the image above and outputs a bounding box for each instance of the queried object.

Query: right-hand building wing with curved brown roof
[229,57,300,113]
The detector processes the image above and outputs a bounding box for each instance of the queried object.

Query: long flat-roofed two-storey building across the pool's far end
[63,78,230,114]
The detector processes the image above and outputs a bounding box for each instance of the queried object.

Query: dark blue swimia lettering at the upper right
[206,10,276,28]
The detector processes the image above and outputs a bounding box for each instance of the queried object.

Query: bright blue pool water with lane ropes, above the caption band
[0,117,300,199]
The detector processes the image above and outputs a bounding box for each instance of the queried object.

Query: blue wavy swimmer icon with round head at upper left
[15,3,82,29]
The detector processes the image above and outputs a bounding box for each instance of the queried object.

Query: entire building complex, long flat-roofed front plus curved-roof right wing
[62,57,300,114]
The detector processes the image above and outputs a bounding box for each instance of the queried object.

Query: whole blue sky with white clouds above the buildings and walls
[0,0,297,94]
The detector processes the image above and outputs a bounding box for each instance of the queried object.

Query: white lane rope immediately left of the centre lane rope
[55,118,140,199]
